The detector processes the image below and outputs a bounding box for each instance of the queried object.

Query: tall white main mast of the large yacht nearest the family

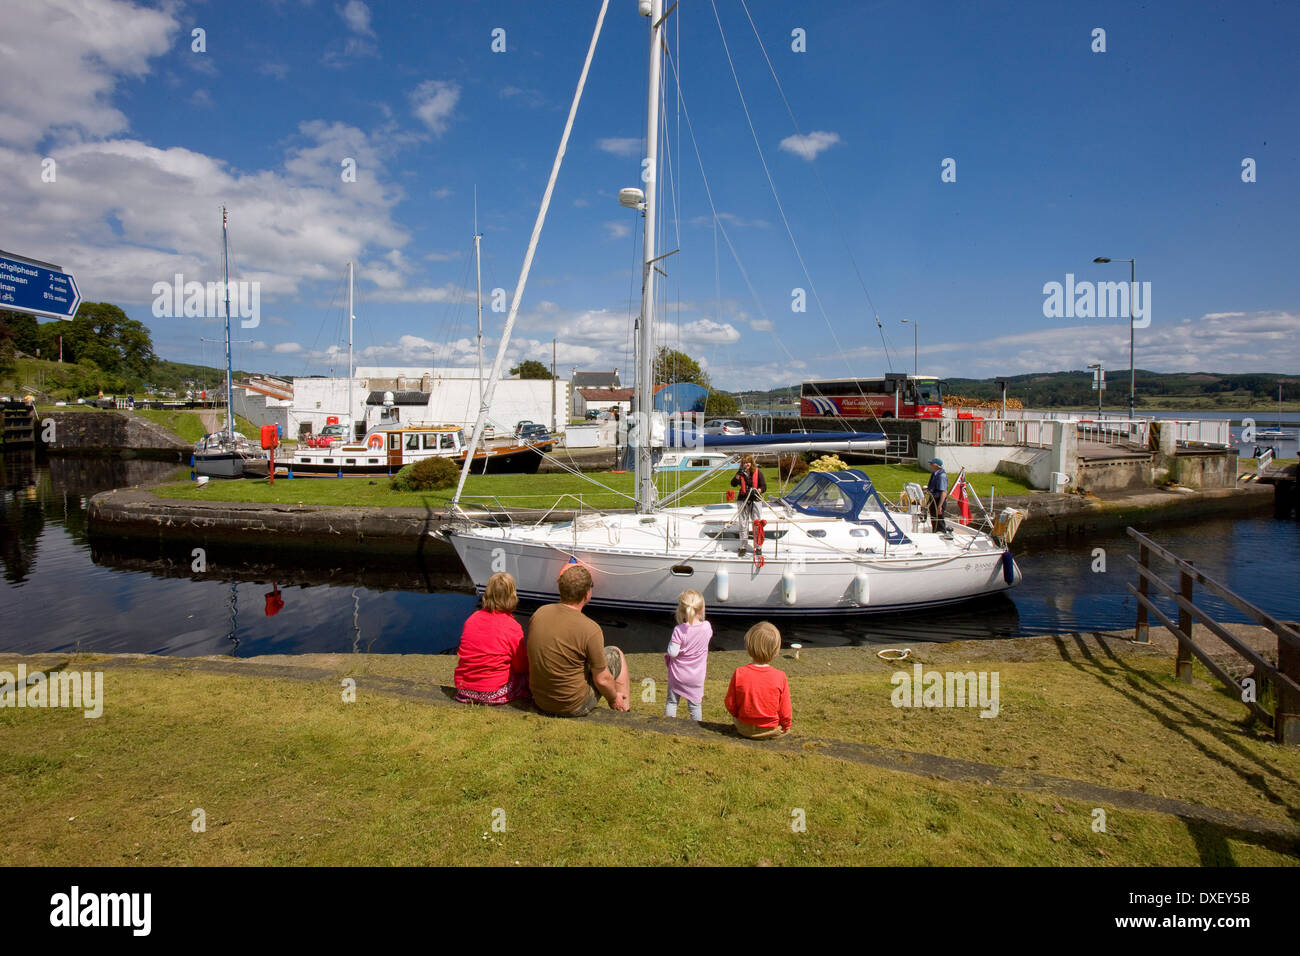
[632,0,663,514]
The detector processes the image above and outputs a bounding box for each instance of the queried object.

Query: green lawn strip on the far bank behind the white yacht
[153,464,1030,509]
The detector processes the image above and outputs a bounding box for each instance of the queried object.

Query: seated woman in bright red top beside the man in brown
[454,574,529,704]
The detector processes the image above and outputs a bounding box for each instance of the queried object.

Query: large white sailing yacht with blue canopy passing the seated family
[441,0,1021,617]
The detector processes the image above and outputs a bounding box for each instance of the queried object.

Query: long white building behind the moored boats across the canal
[235,365,569,437]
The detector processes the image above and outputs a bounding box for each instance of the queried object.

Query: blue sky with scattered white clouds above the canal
[0,0,1300,388]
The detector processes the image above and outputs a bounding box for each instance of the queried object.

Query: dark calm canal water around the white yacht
[0,453,1300,656]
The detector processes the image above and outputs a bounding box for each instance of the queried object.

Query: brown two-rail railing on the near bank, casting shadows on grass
[1125,528,1300,744]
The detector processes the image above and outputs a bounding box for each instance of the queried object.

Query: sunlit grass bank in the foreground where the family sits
[0,639,1300,865]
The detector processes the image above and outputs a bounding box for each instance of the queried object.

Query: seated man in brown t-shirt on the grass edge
[527,564,629,717]
